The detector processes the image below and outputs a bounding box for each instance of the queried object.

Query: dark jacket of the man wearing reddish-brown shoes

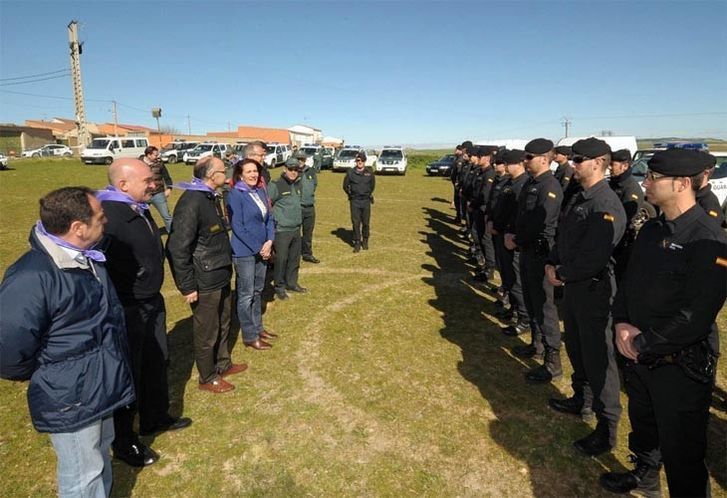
[167,190,232,295]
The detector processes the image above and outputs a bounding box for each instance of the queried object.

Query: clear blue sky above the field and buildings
[0,0,727,144]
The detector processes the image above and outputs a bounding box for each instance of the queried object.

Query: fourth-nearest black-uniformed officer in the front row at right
[489,149,530,336]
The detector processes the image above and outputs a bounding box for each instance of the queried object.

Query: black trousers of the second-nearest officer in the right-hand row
[562,274,621,434]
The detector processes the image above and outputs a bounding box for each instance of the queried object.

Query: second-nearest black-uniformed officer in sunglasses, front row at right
[545,138,626,456]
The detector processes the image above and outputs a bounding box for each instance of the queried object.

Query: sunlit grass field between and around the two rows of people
[0,153,727,497]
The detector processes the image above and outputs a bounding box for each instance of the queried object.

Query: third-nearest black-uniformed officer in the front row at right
[505,138,563,383]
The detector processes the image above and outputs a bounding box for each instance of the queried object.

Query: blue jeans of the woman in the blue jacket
[233,254,268,342]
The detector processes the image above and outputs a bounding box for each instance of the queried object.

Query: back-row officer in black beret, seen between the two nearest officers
[608,149,644,282]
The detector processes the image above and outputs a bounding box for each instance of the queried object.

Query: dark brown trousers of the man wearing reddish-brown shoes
[191,285,232,384]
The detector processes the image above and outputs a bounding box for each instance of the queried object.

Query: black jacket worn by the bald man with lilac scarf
[100,201,164,304]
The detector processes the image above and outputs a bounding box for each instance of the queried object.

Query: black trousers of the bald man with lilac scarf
[114,294,169,450]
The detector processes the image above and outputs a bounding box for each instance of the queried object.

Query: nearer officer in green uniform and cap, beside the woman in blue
[268,163,308,300]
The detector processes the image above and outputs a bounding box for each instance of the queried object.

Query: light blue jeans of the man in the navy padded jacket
[50,416,114,498]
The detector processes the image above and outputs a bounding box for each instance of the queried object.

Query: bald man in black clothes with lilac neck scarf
[97,158,192,467]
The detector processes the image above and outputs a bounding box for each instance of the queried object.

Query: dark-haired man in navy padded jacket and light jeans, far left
[0,187,134,497]
